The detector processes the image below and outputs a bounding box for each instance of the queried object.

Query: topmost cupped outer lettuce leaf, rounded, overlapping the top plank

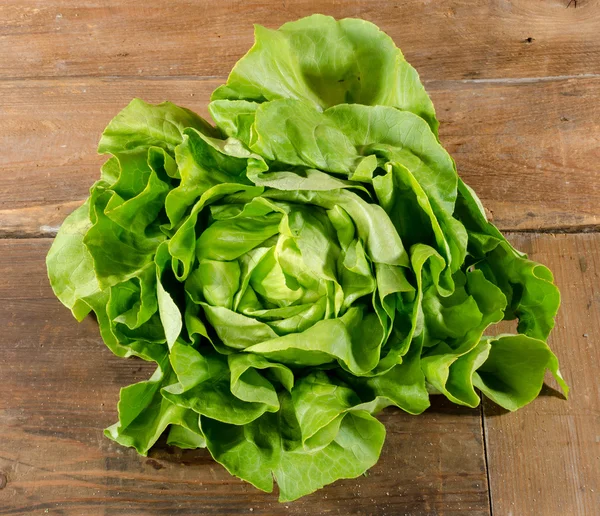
[211,14,438,134]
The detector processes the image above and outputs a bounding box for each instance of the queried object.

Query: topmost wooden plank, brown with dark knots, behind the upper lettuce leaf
[0,0,600,79]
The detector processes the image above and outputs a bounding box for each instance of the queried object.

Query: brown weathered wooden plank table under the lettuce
[0,0,600,516]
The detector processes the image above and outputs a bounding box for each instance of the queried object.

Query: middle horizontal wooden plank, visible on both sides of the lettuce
[0,78,600,236]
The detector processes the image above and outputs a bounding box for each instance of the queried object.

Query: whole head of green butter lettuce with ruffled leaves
[47,15,567,501]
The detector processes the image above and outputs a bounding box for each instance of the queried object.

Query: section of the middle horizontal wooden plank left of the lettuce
[0,79,218,220]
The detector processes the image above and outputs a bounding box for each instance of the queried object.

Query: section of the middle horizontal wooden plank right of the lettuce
[436,78,600,232]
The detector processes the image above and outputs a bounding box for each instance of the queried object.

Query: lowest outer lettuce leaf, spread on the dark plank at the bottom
[202,373,385,502]
